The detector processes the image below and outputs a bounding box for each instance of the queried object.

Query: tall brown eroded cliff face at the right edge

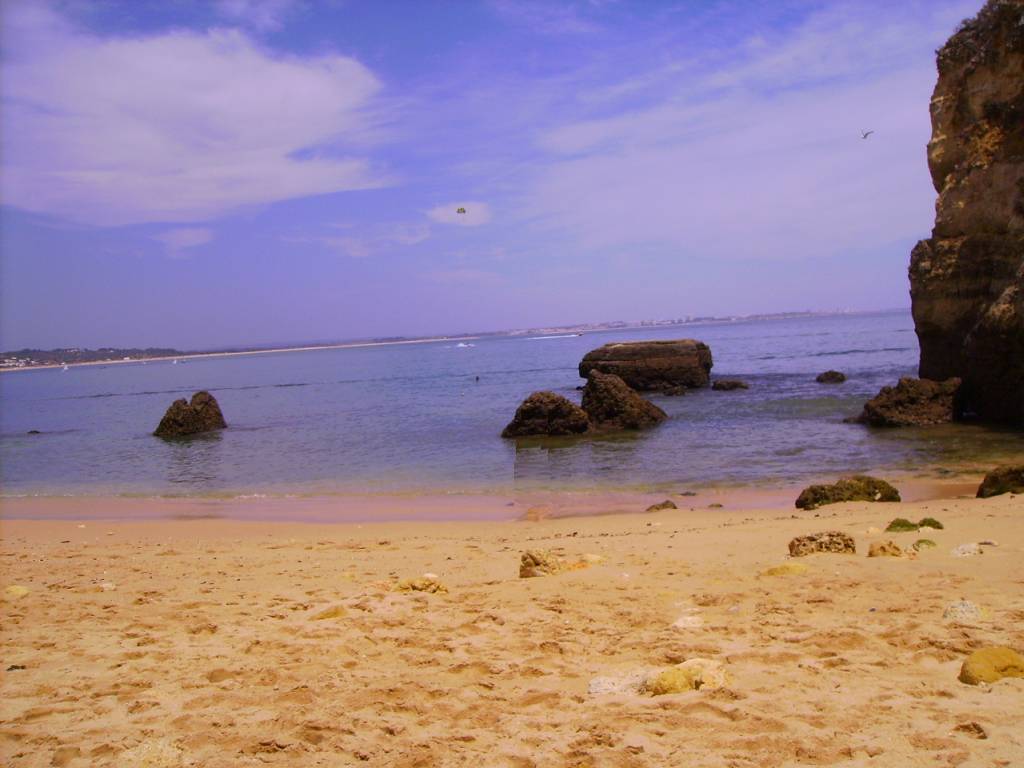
[910,0,1024,425]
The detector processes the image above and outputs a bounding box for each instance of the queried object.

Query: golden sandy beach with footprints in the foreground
[0,496,1024,768]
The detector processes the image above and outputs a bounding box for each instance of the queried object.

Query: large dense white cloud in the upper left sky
[0,3,387,225]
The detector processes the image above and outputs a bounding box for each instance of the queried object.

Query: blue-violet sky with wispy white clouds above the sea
[0,0,981,349]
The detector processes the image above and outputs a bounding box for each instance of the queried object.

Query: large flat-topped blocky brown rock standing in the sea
[580,339,712,392]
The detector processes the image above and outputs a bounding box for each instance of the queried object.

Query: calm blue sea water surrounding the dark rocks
[0,312,1024,497]
